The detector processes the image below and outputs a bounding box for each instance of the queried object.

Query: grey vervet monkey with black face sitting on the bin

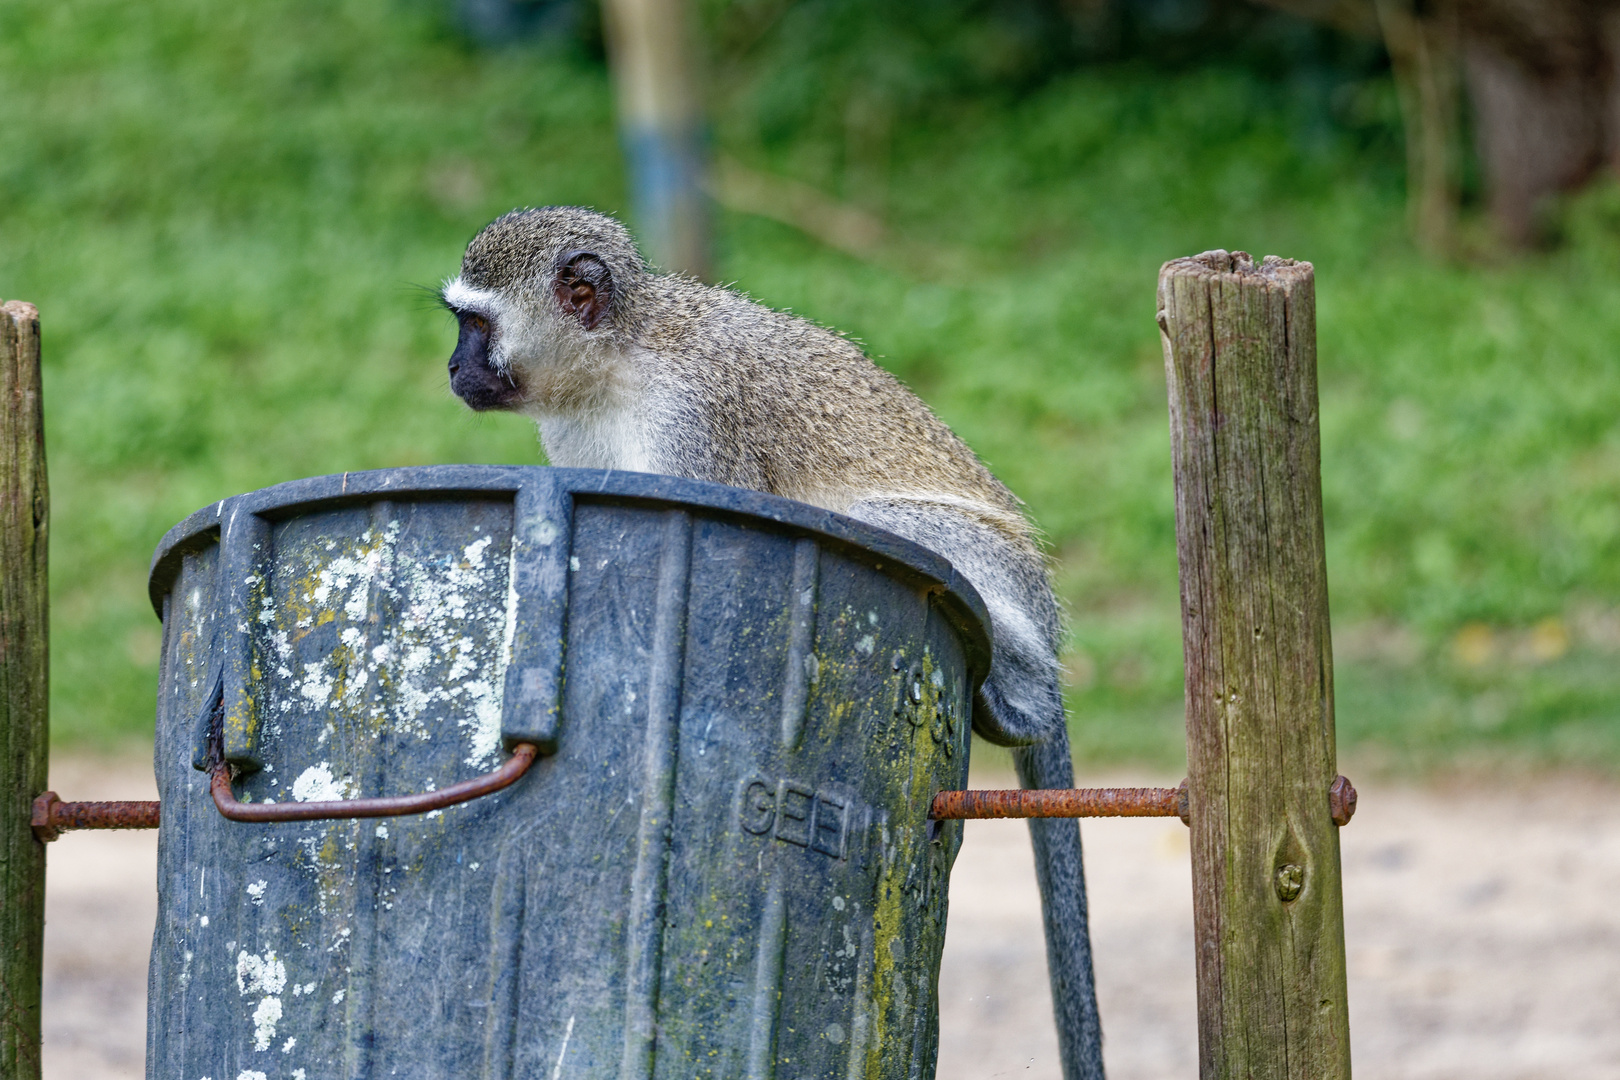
[441,207,1103,1080]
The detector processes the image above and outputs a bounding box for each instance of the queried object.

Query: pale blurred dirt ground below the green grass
[45,758,1620,1080]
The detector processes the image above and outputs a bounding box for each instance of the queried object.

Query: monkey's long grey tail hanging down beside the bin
[1013,724,1103,1080]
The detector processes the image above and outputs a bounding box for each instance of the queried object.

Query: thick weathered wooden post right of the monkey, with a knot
[1158,251,1349,1080]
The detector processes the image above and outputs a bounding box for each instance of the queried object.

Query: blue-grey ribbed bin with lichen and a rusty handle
[147,466,988,1080]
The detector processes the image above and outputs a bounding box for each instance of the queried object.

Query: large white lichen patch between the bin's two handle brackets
[256,518,518,919]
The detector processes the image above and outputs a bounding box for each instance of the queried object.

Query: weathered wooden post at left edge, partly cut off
[0,300,50,1080]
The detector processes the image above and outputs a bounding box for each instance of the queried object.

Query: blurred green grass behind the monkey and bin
[0,0,1620,771]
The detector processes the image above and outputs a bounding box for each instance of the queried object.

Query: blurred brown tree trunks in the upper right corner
[1259,0,1620,251]
